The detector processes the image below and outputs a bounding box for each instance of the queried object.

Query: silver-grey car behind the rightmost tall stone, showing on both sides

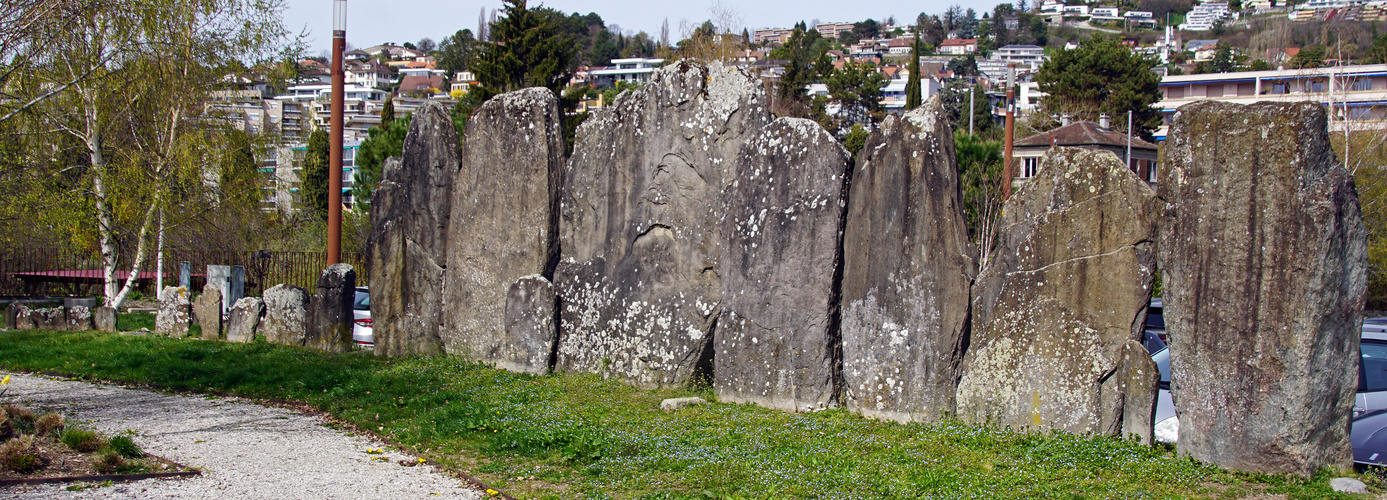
[1151,318,1387,444]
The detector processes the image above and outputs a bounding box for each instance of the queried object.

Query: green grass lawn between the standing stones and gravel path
[0,331,1381,499]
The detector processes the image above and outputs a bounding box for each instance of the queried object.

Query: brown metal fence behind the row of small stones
[0,247,366,297]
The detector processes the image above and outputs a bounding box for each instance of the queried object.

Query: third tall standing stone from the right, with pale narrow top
[842,97,976,422]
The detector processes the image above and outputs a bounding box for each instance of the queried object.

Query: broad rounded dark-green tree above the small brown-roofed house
[1036,36,1161,138]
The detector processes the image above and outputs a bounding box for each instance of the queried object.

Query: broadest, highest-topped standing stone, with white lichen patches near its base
[555,61,770,388]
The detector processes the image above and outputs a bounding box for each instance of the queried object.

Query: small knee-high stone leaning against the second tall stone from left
[492,275,559,375]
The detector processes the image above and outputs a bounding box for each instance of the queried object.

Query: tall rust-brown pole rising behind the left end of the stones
[327,0,347,265]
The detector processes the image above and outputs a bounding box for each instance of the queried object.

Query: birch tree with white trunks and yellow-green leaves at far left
[0,0,293,307]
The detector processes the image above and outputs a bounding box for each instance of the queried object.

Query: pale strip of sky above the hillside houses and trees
[284,0,970,54]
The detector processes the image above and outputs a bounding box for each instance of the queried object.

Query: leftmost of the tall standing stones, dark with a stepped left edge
[366,101,457,356]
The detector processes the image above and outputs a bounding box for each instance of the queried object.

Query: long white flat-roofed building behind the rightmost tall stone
[1155,64,1387,140]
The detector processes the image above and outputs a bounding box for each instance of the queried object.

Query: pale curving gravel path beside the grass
[0,374,485,499]
